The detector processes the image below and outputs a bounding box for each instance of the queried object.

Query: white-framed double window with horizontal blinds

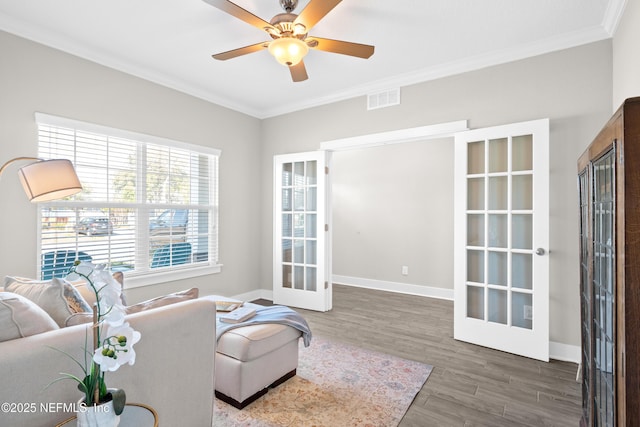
[36,114,220,286]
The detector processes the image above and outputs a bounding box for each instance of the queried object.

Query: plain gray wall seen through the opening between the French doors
[332,138,454,288]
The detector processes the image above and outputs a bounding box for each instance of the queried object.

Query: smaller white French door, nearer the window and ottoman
[273,151,332,311]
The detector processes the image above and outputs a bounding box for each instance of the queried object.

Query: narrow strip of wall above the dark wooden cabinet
[613,0,640,111]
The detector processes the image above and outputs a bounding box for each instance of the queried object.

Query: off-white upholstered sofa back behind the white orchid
[0,299,216,427]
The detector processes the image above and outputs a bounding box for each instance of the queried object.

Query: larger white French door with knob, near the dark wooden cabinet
[454,119,549,361]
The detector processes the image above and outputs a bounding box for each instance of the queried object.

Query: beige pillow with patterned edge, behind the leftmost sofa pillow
[4,276,91,327]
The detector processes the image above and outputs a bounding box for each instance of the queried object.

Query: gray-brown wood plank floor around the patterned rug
[258,285,581,427]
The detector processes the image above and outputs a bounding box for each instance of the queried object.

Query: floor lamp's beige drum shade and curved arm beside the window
[0,157,82,203]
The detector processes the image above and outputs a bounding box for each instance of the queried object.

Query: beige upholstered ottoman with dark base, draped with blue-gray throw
[215,323,302,409]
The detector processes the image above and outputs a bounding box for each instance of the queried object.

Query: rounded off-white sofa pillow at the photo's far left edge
[0,292,58,341]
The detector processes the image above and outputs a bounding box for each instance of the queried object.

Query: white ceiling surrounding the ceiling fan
[0,0,626,118]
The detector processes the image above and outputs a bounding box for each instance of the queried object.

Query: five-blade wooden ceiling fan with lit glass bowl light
[204,0,374,82]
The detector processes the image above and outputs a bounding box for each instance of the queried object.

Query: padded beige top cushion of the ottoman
[216,323,301,362]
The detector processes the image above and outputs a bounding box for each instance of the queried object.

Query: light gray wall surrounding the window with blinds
[0,32,260,302]
